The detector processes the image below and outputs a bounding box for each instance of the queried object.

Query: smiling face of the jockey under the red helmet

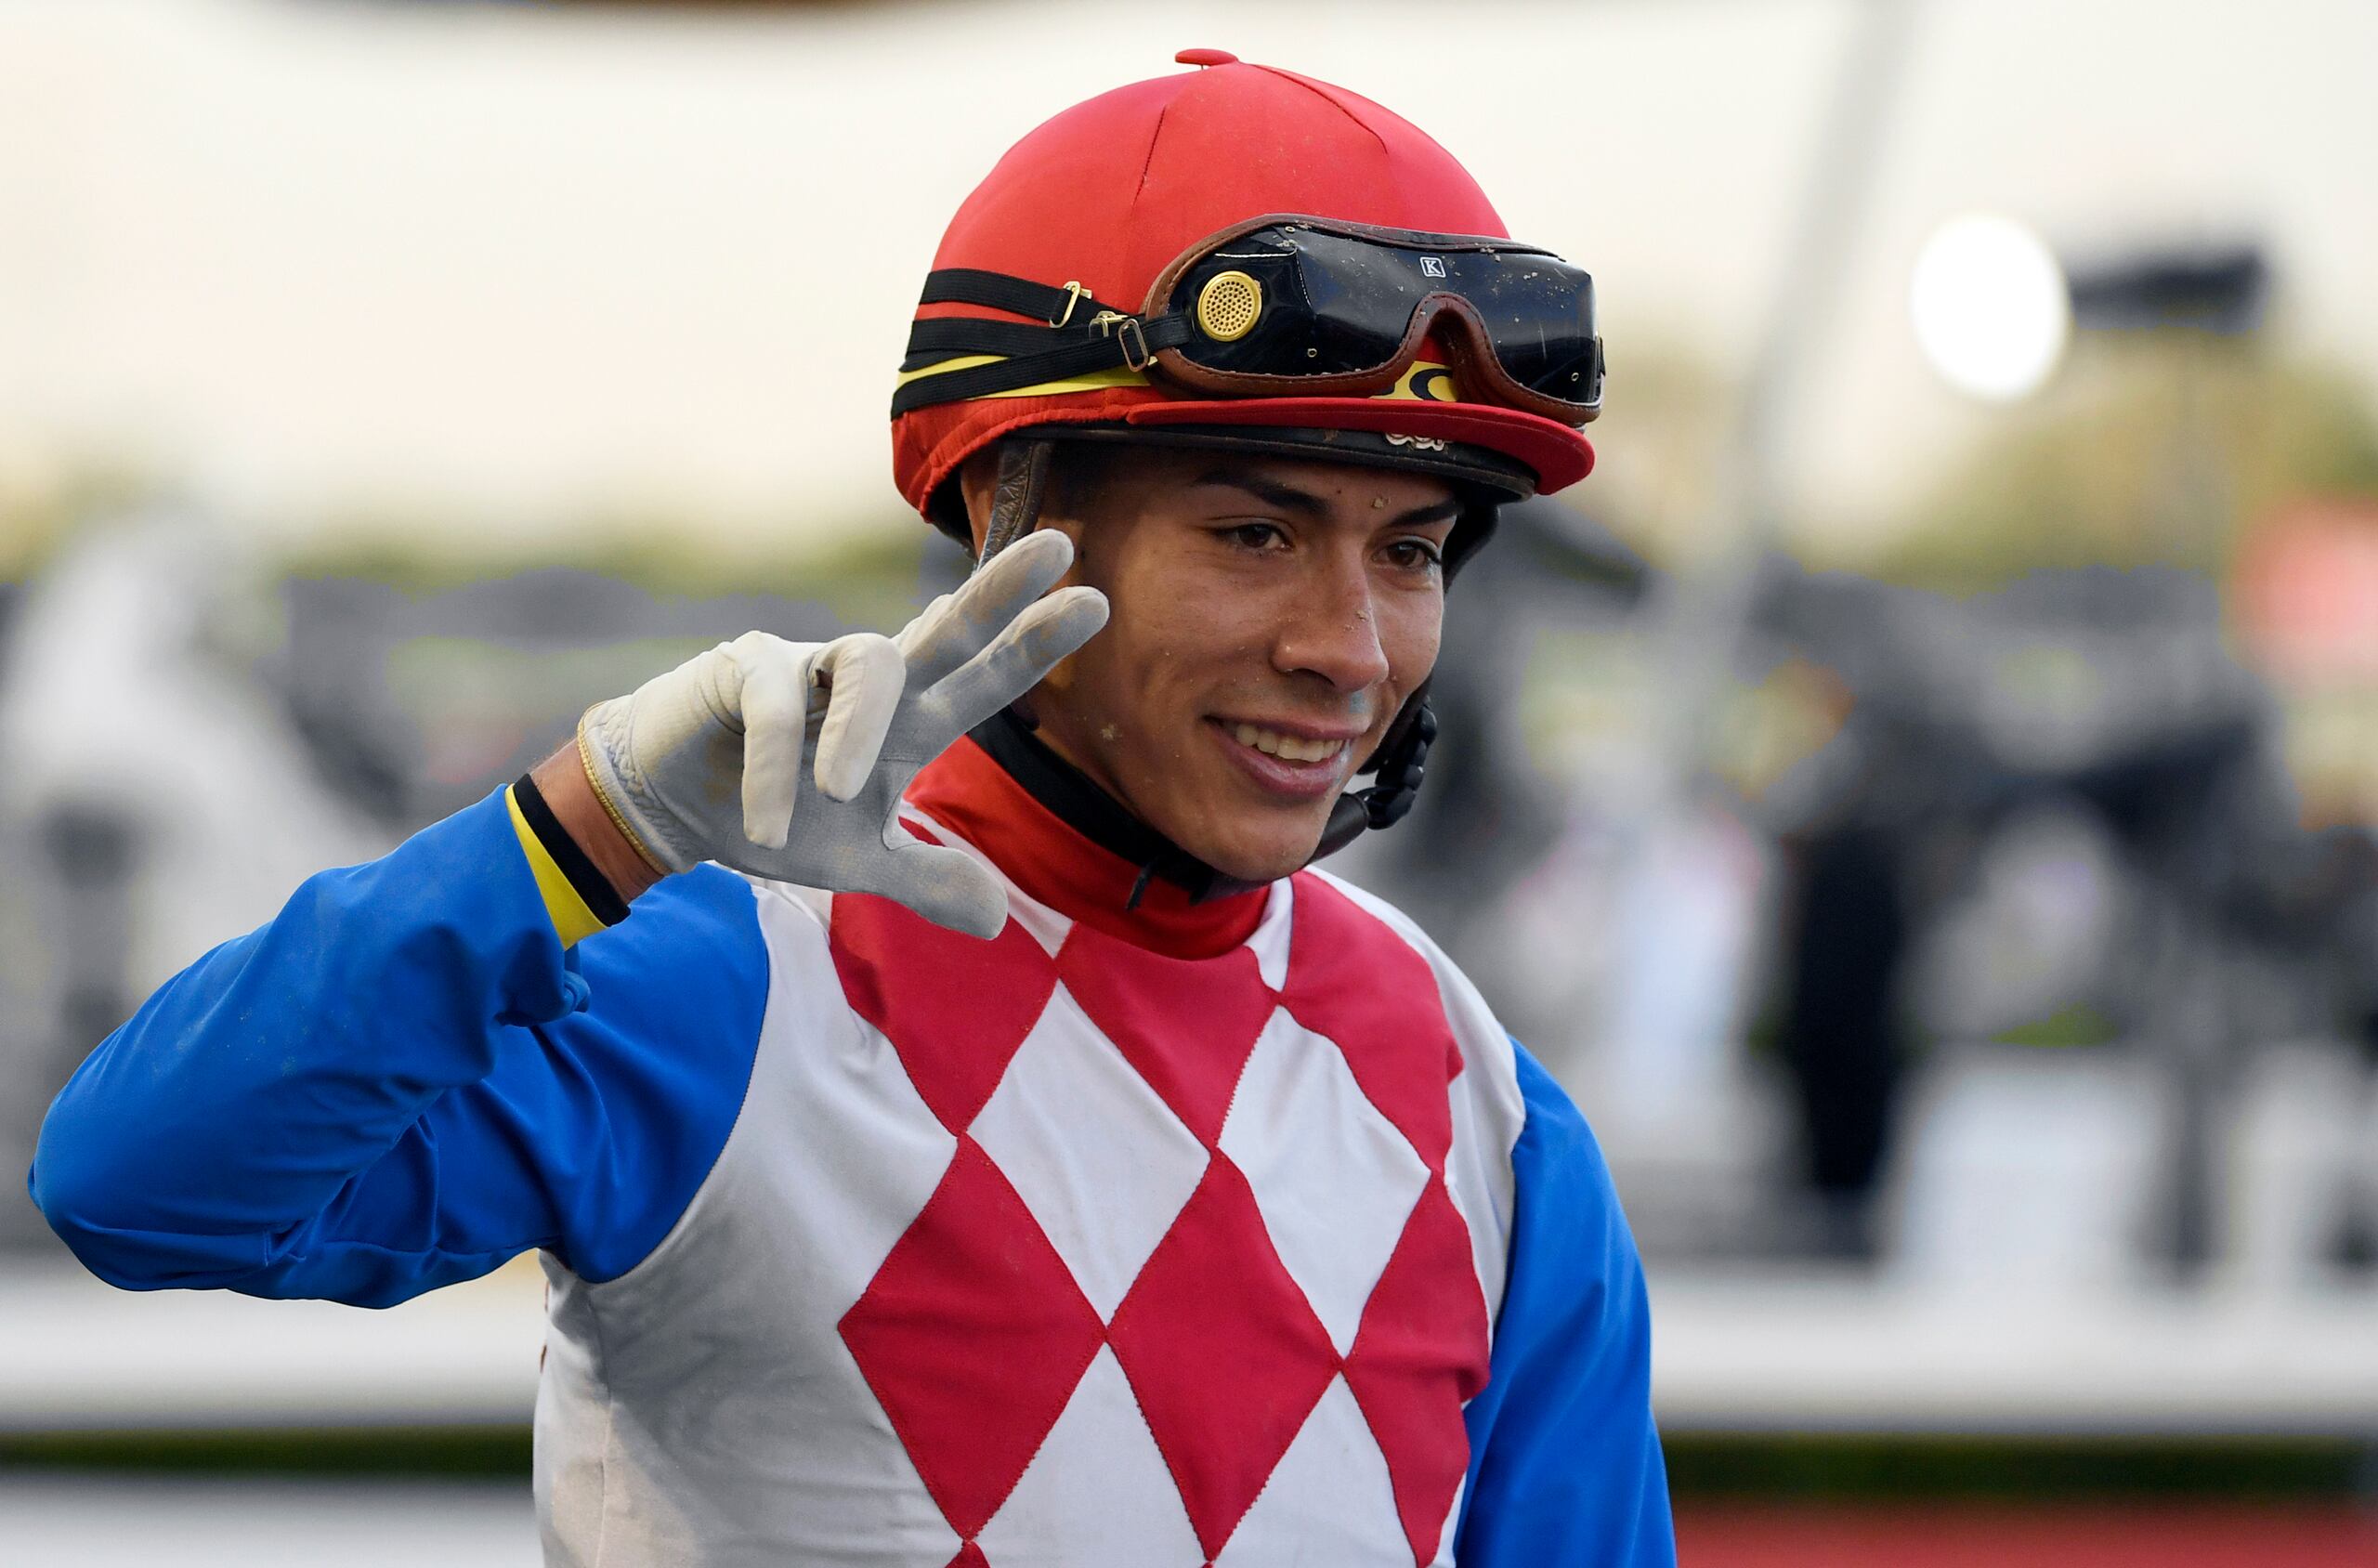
[965,448,1457,881]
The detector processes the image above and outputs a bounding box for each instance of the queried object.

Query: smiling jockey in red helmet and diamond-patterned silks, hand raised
[31,50,1674,1568]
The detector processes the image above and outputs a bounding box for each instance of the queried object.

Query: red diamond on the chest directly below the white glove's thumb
[832,893,1056,1132]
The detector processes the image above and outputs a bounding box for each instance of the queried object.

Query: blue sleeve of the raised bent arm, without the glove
[31,792,768,1306]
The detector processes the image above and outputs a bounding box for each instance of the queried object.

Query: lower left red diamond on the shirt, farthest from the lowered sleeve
[842,1137,1101,1539]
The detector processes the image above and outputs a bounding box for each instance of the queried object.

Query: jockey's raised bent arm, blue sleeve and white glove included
[31,533,1105,1304]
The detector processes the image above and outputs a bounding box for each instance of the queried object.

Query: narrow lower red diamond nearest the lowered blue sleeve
[1346,1180,1486,1563]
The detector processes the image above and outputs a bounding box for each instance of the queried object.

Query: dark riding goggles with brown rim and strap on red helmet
[892,215,1602,426]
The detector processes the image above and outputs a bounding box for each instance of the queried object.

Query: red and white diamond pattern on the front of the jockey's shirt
[830,876,1486,1568]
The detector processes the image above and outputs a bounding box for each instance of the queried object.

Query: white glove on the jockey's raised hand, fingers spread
[578,533,1105,937]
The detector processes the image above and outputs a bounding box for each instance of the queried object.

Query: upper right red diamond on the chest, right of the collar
[1279,876,1462,1170]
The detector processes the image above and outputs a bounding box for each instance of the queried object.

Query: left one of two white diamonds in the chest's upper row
[970,985,1213,1318]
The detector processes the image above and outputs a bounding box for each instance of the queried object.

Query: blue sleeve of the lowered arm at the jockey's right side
[1453,1044,1677,1568]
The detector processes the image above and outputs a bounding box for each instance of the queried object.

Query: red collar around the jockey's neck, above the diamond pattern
[908,738,1270,959]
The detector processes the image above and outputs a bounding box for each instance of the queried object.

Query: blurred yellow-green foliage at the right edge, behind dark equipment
[1864,342,2378,593]
